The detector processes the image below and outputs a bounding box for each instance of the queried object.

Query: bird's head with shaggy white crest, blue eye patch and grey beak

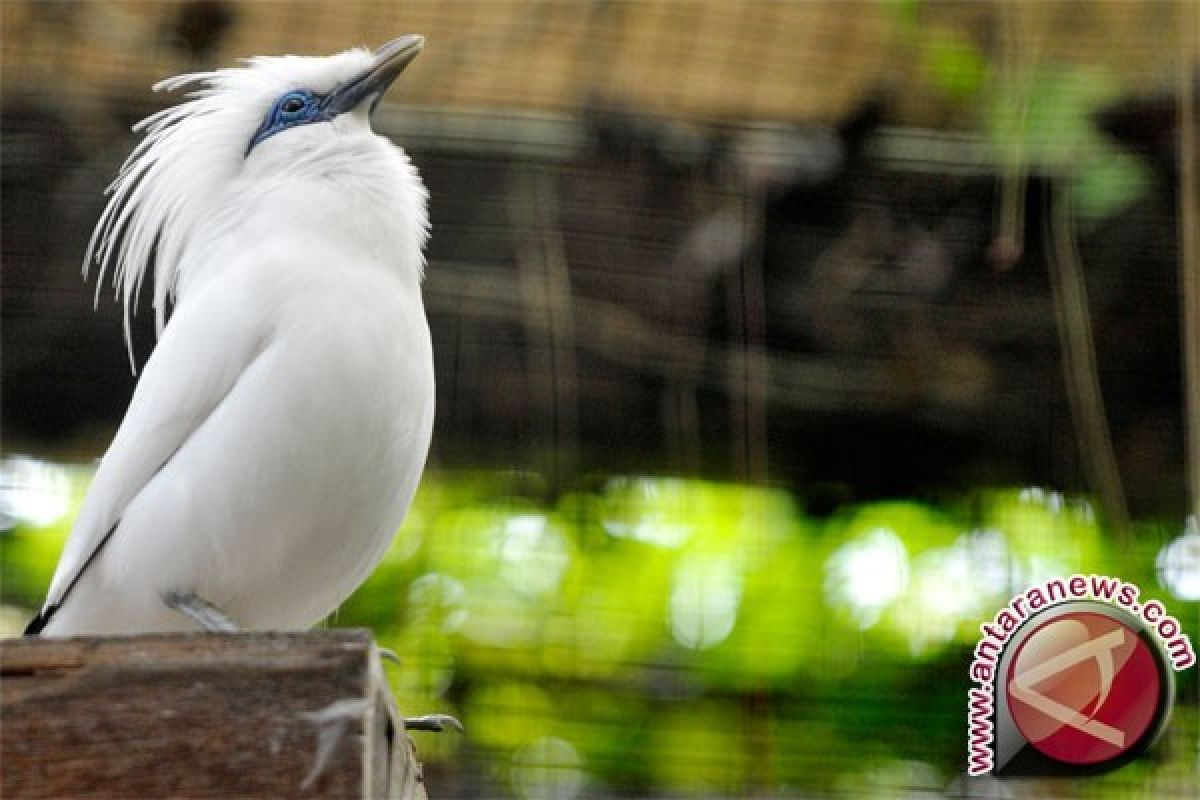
[84,35,427,362]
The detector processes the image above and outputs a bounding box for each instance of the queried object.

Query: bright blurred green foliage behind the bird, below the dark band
[0,470,1200,798]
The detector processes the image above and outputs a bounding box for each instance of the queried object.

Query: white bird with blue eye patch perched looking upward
[26,36,434,636]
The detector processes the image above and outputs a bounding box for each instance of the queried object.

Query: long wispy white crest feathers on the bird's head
[83,48,428,366]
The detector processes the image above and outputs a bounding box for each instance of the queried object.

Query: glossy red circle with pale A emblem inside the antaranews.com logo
[1004,610,1163,764]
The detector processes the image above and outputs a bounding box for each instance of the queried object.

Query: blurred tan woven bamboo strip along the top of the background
[4,0,1178,126]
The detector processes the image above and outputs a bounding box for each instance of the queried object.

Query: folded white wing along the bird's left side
[41,281,268,621]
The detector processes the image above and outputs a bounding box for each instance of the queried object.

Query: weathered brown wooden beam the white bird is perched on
[0,631,426,800]
